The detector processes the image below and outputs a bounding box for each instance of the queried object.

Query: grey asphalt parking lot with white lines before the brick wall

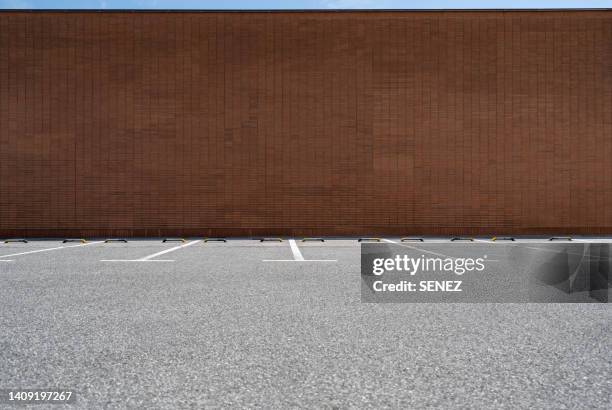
[0,238,612,409]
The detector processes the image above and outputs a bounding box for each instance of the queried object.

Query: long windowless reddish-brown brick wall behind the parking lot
[0,11,612,236]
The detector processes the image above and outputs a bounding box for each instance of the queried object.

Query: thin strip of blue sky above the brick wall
[0,0,612,9]
